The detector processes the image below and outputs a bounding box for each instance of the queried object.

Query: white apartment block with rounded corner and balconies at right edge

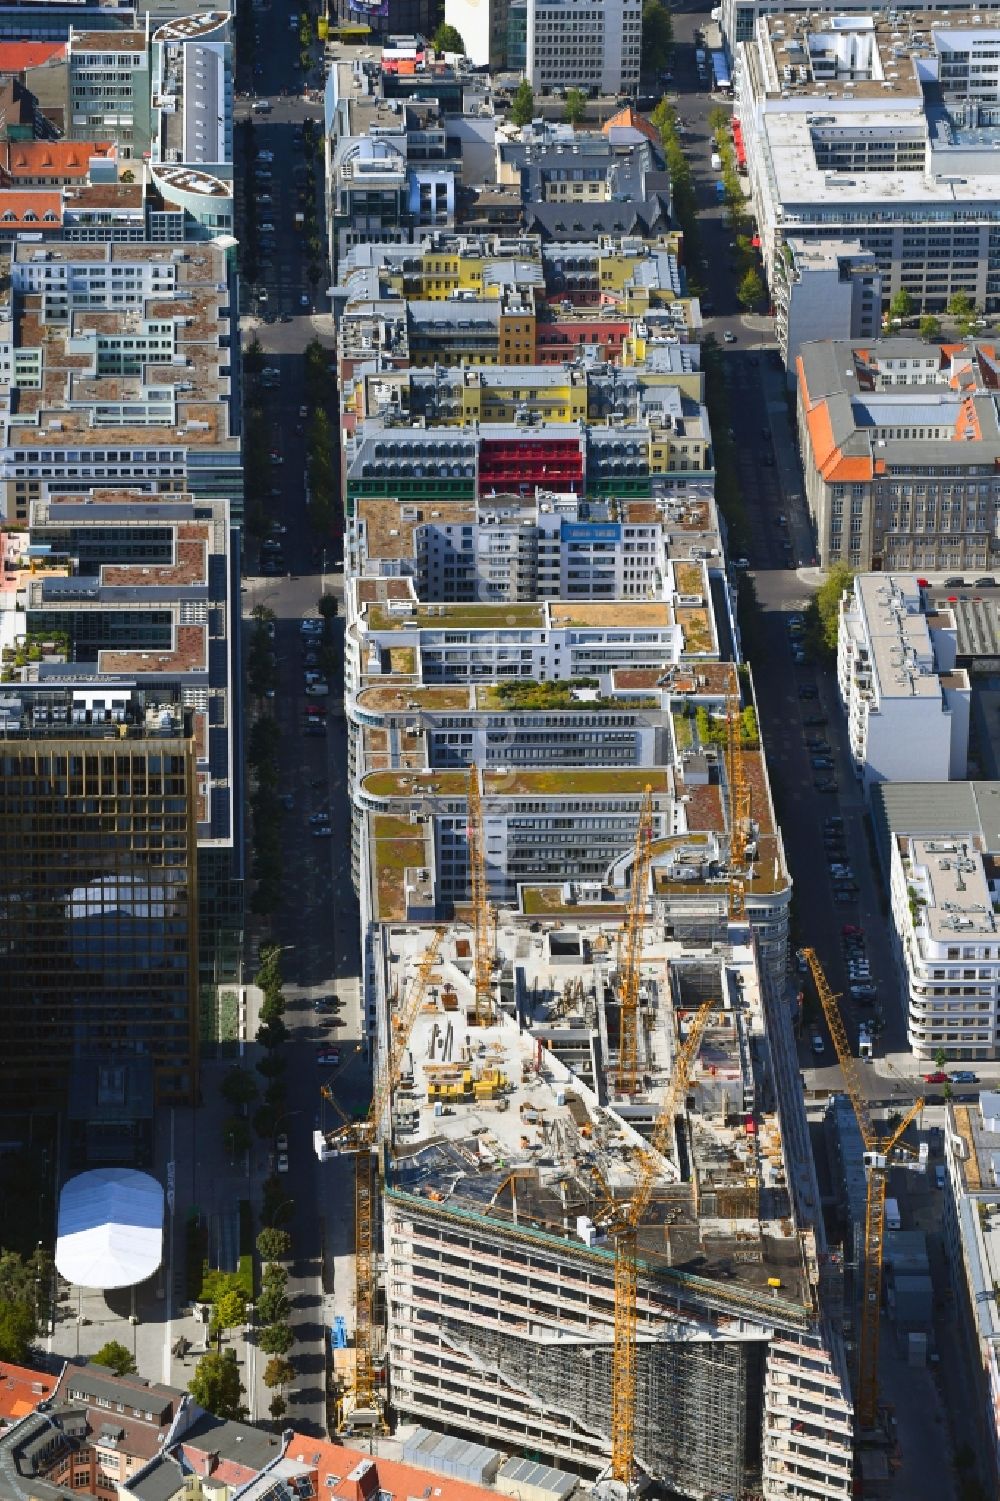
[889,829,1000,1060]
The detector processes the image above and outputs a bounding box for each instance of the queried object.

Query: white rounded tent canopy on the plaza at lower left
[56,1168,164,1291]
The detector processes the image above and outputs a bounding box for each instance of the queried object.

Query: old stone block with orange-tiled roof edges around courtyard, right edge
[796,339,1000,573]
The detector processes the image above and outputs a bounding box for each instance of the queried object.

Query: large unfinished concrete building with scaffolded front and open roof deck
[369,916,853,1501]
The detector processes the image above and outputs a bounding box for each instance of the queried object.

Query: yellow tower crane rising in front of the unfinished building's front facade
[599,1000,719,1490]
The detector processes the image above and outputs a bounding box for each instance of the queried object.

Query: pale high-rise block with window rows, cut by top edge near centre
[524,0,643,95]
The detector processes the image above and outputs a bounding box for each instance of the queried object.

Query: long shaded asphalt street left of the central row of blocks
[237,6,371,1435]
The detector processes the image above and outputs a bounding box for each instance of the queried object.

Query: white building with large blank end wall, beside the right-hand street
[836,573,970,796]
